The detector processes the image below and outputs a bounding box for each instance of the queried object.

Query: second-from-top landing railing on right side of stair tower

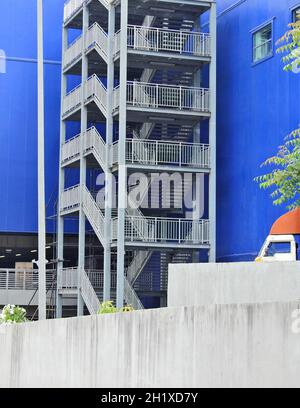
[125,81,209,112]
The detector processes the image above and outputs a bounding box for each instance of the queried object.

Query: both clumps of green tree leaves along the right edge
[255,22,300,210]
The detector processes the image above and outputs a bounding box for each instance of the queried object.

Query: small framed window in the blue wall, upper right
[253,23,273,63]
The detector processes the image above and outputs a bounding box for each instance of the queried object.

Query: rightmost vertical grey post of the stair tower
[209,2,217,262]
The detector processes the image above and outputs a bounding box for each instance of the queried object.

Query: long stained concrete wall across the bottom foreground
[0,303,300,388]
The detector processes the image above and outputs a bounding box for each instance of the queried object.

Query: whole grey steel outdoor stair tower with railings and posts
[57,0,216,317]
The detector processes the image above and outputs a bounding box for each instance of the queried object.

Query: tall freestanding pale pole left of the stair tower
[37,0,46,320]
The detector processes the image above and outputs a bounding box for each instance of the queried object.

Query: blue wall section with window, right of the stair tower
[217,0,300,261]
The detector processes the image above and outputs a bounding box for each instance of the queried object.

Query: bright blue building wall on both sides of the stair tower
[0,0,300,261]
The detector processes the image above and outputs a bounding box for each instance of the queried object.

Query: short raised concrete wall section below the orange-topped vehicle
[168,262,300,307]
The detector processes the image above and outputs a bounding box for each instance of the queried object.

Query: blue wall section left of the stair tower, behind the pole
[0,0,64,232]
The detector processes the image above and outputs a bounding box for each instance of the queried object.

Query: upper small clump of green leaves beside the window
[277,22,300,71]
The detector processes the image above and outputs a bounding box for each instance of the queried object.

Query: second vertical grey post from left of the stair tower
[77,4,89,316]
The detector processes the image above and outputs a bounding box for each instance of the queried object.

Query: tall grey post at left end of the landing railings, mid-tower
[117,0,128,308]
